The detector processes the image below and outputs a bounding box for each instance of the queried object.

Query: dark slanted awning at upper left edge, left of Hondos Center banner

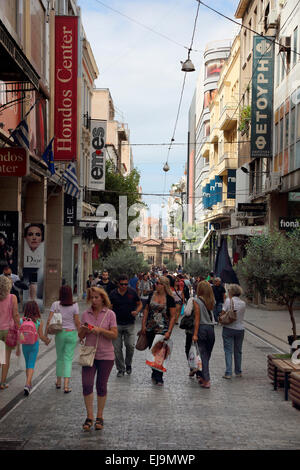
[0,20,40,90]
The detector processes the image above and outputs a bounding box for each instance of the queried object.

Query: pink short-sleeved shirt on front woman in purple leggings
[81,308,117,361]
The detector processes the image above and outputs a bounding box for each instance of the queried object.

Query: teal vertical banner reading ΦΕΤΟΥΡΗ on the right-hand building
[251,36,274,158]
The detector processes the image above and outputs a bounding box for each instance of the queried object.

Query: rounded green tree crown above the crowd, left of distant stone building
[97,247,149,280]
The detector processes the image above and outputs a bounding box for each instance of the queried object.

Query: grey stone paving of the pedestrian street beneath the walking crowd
[0,314,300,450]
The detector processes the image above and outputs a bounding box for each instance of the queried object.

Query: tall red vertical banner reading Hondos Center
[54,16,78,161]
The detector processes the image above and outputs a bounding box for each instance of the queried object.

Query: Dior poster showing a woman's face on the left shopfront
[23,223,45,310]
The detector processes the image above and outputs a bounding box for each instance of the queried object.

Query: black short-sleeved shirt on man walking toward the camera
[109,287,140,325]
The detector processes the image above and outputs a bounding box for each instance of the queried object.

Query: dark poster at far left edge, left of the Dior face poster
[0,211,19,274]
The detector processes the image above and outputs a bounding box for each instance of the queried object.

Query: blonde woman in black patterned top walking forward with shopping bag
[142,276,176,386]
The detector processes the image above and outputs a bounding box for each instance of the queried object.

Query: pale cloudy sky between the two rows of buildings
[77,0,239,210]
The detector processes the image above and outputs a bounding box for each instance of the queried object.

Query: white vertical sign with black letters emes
[88,119,107,191]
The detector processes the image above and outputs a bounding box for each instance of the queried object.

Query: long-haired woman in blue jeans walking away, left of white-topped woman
[193,281,215,388]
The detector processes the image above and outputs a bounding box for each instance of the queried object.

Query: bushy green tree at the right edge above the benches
[237,230,300,339]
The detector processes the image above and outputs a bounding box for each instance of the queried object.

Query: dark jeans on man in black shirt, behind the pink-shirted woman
[113,323,136,372]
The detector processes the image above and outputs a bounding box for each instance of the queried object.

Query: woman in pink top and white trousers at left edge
[0,276,20,390]
